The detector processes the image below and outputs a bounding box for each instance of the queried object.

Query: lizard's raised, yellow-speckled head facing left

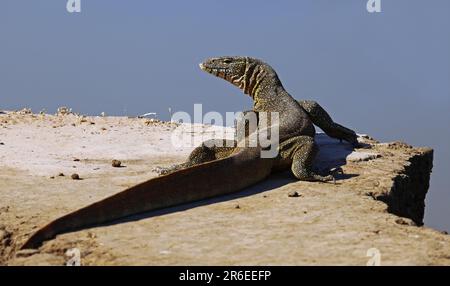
[200,57,278,97]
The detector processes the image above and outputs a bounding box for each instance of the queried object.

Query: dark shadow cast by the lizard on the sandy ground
[99,134,358,226]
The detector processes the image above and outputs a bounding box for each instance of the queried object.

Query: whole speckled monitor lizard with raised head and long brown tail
[22,57,356,249]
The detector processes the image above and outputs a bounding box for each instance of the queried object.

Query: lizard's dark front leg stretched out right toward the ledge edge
[298,100,358,146]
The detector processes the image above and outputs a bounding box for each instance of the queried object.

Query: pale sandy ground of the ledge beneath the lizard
[0,112,450,265]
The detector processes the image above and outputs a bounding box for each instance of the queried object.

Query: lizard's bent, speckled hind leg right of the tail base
[279,136,335,182]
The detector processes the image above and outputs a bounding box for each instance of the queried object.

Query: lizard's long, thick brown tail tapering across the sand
[22,148,271,249]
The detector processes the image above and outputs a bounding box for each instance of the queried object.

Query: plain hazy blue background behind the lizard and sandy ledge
[0,0,450,230]
